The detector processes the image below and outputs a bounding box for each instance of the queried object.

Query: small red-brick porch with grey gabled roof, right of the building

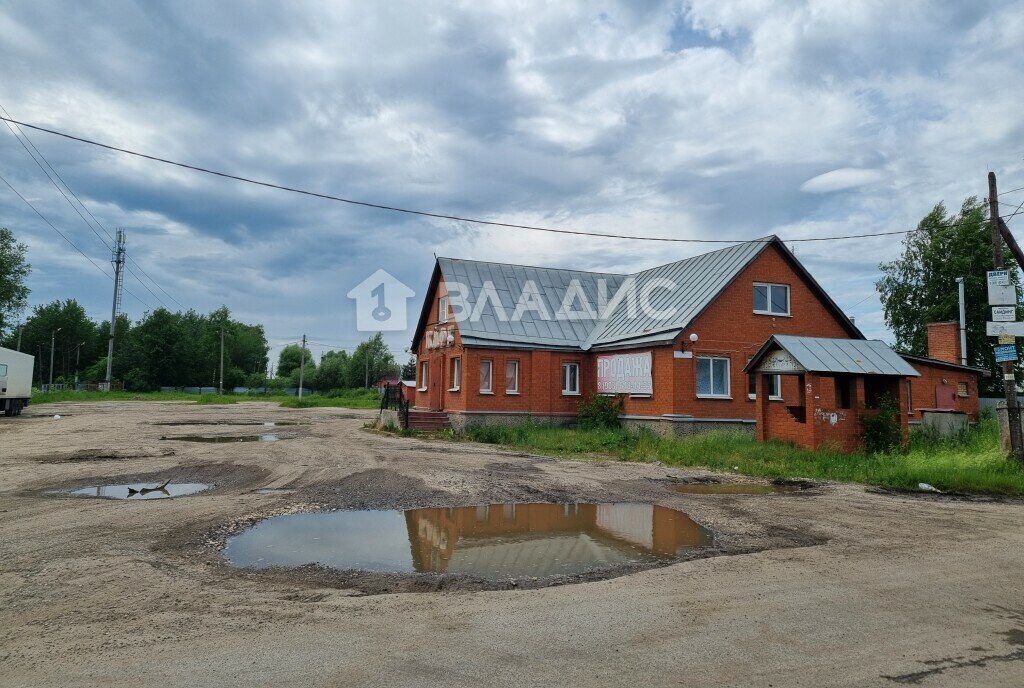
[743,335,920,452]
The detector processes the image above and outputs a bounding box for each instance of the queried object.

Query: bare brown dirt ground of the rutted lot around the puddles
[0,402,1024,686]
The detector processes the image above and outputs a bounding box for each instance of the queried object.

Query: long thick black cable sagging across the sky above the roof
[0,117,958,244]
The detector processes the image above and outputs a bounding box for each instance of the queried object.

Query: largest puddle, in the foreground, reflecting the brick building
[224,504,714,579]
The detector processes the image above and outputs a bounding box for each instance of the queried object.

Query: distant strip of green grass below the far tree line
[31,389,381,409]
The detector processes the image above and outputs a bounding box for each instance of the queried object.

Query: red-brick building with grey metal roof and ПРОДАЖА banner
[413,237,979,444]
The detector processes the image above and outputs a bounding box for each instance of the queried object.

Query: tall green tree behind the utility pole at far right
[876,197,1021,393]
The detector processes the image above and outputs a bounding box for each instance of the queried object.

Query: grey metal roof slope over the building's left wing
[437,258,625,348]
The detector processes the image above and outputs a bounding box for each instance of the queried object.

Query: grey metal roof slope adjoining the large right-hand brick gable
[584,237,772,349]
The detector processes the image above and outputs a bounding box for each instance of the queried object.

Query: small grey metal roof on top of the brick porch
[743,335,921,378]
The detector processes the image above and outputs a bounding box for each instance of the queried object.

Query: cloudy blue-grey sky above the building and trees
[0,0,1024,362]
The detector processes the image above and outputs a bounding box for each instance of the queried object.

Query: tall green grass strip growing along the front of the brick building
[468,420,1024,495]
